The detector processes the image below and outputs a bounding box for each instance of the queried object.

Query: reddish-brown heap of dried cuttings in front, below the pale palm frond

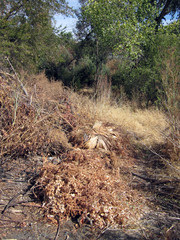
[36,149,146,228]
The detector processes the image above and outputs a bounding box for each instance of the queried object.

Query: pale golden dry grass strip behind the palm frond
[71,95,169,147]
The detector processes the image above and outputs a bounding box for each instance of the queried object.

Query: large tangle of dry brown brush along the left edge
[0,73,74,156]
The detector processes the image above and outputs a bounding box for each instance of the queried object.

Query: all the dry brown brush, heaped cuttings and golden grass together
[0,72,179,229]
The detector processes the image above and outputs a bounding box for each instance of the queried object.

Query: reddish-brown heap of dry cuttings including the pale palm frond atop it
[36,122,145,229]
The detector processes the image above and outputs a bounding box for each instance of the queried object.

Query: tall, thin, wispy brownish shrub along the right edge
[161,47,180,173]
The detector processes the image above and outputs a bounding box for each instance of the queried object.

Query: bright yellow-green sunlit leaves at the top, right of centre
[86,0,157,58]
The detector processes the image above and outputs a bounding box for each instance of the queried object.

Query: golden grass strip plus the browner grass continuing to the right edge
[71,83,180,177]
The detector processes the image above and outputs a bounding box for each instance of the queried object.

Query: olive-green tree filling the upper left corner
[0,0,71,69]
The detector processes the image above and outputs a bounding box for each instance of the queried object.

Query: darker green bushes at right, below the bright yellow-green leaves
[112,21,180,109]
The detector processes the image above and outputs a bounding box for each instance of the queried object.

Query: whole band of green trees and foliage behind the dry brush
[0,0,179,109]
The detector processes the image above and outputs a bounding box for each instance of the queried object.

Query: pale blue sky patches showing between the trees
[54,0,80,32]
